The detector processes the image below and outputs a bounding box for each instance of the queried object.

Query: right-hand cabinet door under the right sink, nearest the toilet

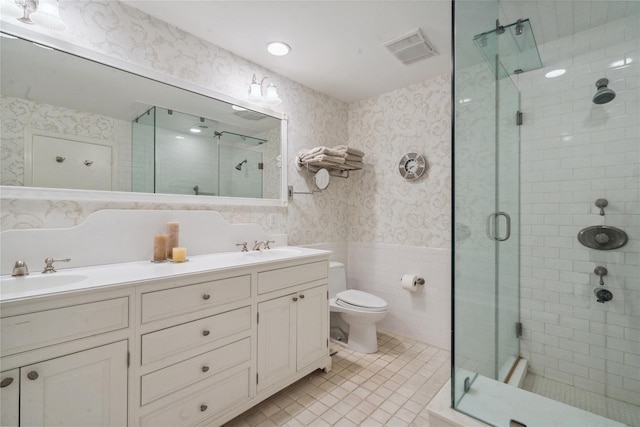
[297,286,329,369]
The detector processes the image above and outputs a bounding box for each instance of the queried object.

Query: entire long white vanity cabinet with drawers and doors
[0,248,331,427]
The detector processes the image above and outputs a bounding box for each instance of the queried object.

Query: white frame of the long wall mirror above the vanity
[0,21,289,207]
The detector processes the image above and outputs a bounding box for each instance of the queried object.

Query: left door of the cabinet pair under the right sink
[258,295,298,391]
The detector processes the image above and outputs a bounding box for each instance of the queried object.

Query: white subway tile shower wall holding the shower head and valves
[516,15,640,405]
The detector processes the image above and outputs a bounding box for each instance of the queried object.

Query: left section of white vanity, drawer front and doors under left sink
[0,292,129,427]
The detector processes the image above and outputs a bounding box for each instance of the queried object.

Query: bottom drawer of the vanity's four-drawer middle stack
[140,369,249,427]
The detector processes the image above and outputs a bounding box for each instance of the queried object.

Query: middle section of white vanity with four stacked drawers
[138,270,255,427]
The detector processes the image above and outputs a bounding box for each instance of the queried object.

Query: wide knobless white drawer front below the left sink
[1,297,129,356]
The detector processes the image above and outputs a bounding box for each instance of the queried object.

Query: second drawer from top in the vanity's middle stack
[142,307,251,364]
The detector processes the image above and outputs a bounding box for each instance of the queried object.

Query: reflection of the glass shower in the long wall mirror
[132,107,264,198]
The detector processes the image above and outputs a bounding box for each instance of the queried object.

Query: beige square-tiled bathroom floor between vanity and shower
[226,333,451,427]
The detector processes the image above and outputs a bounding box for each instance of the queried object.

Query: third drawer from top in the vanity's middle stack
[141,338,251,405]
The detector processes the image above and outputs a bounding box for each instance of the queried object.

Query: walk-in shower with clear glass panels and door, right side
[451,0,640,426]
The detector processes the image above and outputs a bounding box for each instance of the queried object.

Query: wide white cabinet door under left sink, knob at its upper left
[20,341,127,426]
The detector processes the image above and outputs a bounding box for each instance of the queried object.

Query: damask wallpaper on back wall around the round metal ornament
[348,75,451,248]
